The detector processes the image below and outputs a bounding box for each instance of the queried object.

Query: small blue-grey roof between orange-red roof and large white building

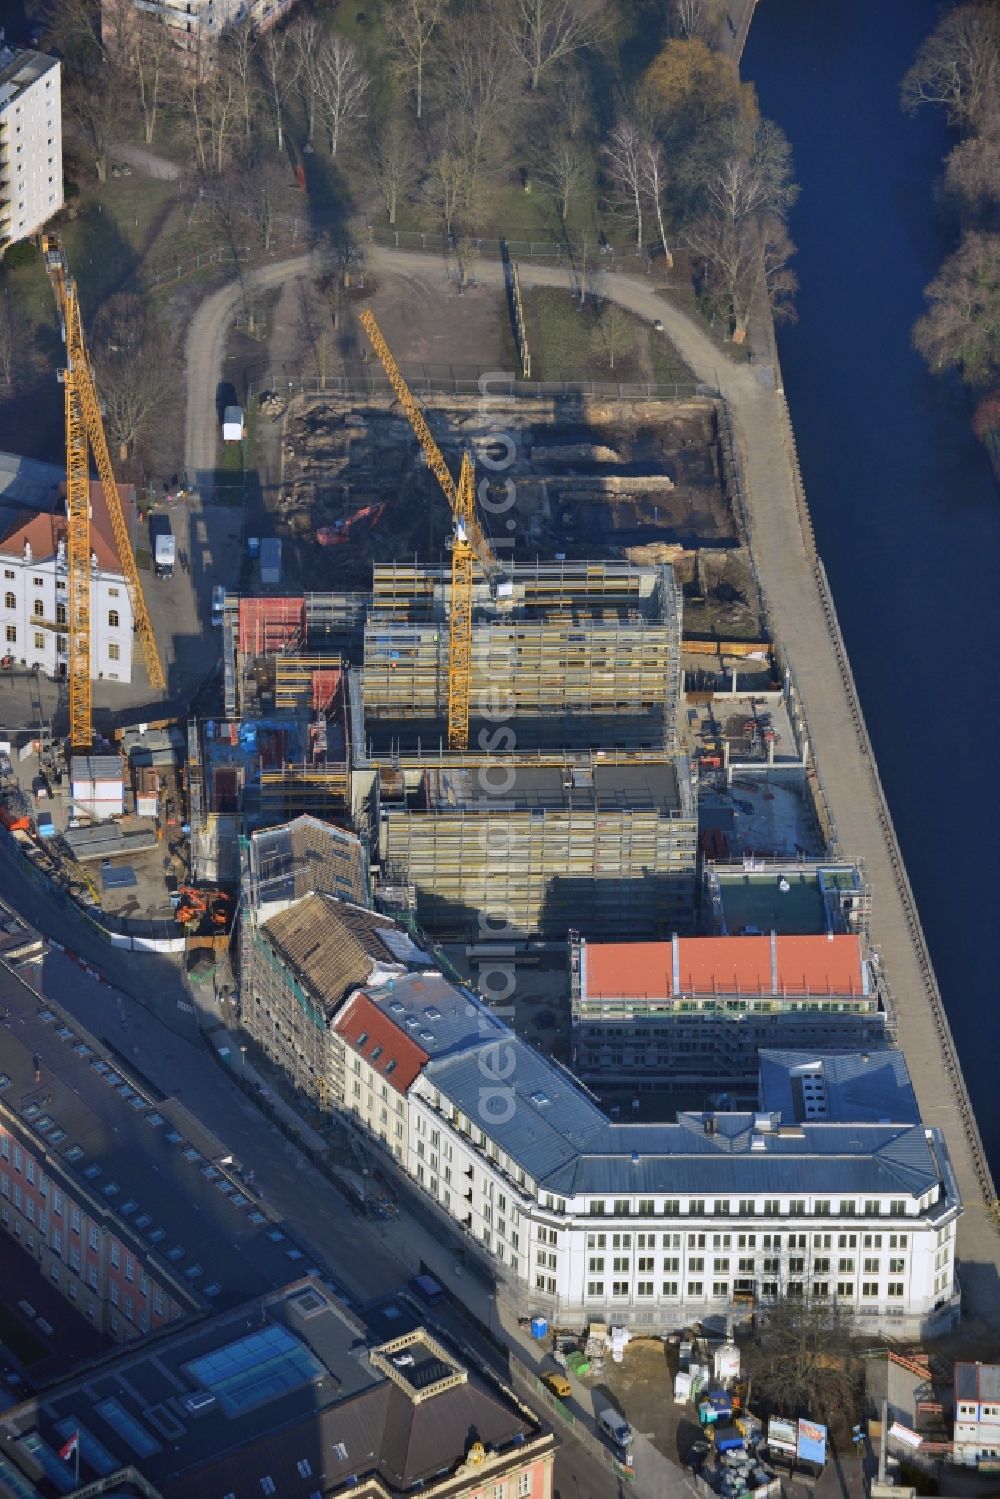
[760,1046,921,1124]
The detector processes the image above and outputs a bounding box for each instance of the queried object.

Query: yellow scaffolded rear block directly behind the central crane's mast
[361,562,681,751]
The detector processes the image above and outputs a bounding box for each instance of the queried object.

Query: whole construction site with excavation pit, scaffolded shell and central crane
[0,278,823,971]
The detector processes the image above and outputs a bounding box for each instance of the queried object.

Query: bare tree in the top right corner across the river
[901,0,1000,126]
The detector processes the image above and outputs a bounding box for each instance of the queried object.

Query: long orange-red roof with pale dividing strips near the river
[583,935,865,1000]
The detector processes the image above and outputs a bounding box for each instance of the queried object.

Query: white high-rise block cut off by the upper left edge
[0,46,63,249]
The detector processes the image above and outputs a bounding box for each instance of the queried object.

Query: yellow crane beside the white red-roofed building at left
[42,234,166,750]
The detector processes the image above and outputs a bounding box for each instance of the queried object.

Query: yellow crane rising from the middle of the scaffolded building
[360,307,501,750]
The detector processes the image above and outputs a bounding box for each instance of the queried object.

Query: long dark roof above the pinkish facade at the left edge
[0,964,325,1309]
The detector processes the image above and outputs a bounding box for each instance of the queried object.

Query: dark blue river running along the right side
[742,0,1000,1157]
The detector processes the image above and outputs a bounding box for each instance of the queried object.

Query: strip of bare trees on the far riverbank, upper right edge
[903,0,1000,472]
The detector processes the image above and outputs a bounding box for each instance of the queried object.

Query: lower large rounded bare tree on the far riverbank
[913,229,1000,385]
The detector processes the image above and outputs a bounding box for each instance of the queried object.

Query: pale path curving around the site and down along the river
[186,246,1000,1325]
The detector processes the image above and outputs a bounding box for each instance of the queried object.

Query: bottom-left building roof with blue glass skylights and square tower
[0,1279,550,1499]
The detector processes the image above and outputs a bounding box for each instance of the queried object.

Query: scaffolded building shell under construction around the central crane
[189,561,697,937]
